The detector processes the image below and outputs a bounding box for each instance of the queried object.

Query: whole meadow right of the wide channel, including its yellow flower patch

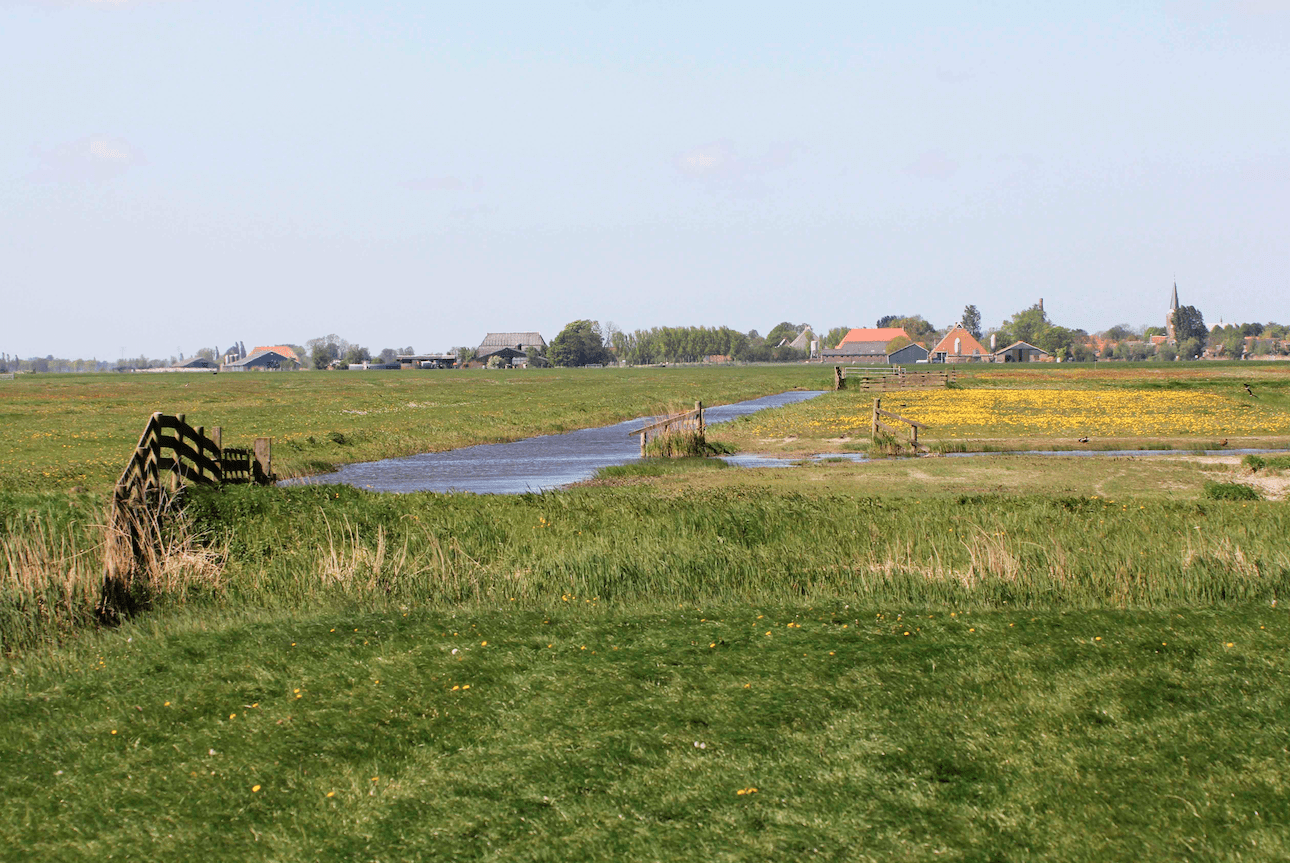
[715,362,1290,453]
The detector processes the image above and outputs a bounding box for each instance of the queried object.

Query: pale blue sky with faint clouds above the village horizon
[0,0,1290,360]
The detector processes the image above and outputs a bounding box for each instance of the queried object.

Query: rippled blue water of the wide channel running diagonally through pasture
[284,390,820,494]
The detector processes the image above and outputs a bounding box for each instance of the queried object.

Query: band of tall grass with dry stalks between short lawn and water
[181,486,1290,608]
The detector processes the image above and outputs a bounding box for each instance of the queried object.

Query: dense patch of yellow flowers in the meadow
[748,390,1290,439]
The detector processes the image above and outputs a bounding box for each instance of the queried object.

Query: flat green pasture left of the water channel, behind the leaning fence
[0,365,829,491]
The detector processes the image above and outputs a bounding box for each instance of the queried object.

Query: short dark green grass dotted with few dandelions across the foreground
[0,596,1290,860]
